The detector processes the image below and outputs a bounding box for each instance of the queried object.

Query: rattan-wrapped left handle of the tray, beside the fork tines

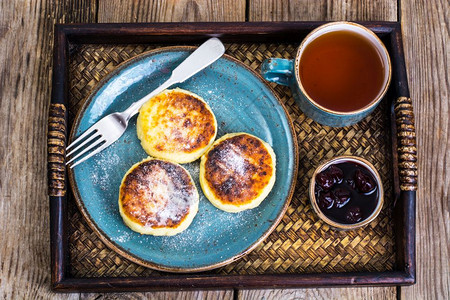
[47,103,66,197]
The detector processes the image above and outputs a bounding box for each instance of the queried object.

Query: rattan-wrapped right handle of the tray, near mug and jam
[394,97,417,191]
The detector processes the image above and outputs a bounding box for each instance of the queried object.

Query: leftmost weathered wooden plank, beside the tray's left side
[0,0,95,299]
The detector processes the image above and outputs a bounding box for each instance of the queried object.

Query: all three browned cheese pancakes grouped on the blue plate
[119,89,276,235]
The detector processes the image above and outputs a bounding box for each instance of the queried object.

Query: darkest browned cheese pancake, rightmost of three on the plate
[200,133,276,212]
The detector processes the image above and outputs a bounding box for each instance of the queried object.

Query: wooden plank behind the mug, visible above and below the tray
[246,0,397,299]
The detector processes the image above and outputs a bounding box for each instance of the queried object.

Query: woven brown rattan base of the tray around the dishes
[68,43,396,277]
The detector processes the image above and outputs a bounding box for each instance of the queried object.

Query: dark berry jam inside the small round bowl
[314,161,379,224]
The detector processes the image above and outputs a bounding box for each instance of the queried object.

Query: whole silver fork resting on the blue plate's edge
[66,38,225,168]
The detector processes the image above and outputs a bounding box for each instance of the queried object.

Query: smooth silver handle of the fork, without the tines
[124,38,225,121]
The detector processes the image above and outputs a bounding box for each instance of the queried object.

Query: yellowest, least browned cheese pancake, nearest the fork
[136,88,217,163]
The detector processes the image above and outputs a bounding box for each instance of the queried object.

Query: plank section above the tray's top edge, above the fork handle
[98,0,245,23]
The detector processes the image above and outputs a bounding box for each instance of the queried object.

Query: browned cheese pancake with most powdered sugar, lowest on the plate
[119,158,199,235]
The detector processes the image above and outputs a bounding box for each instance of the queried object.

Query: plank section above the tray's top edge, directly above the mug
[248,0,397,21]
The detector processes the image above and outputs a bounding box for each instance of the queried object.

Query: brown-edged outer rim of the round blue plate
[67,46,299,273]
